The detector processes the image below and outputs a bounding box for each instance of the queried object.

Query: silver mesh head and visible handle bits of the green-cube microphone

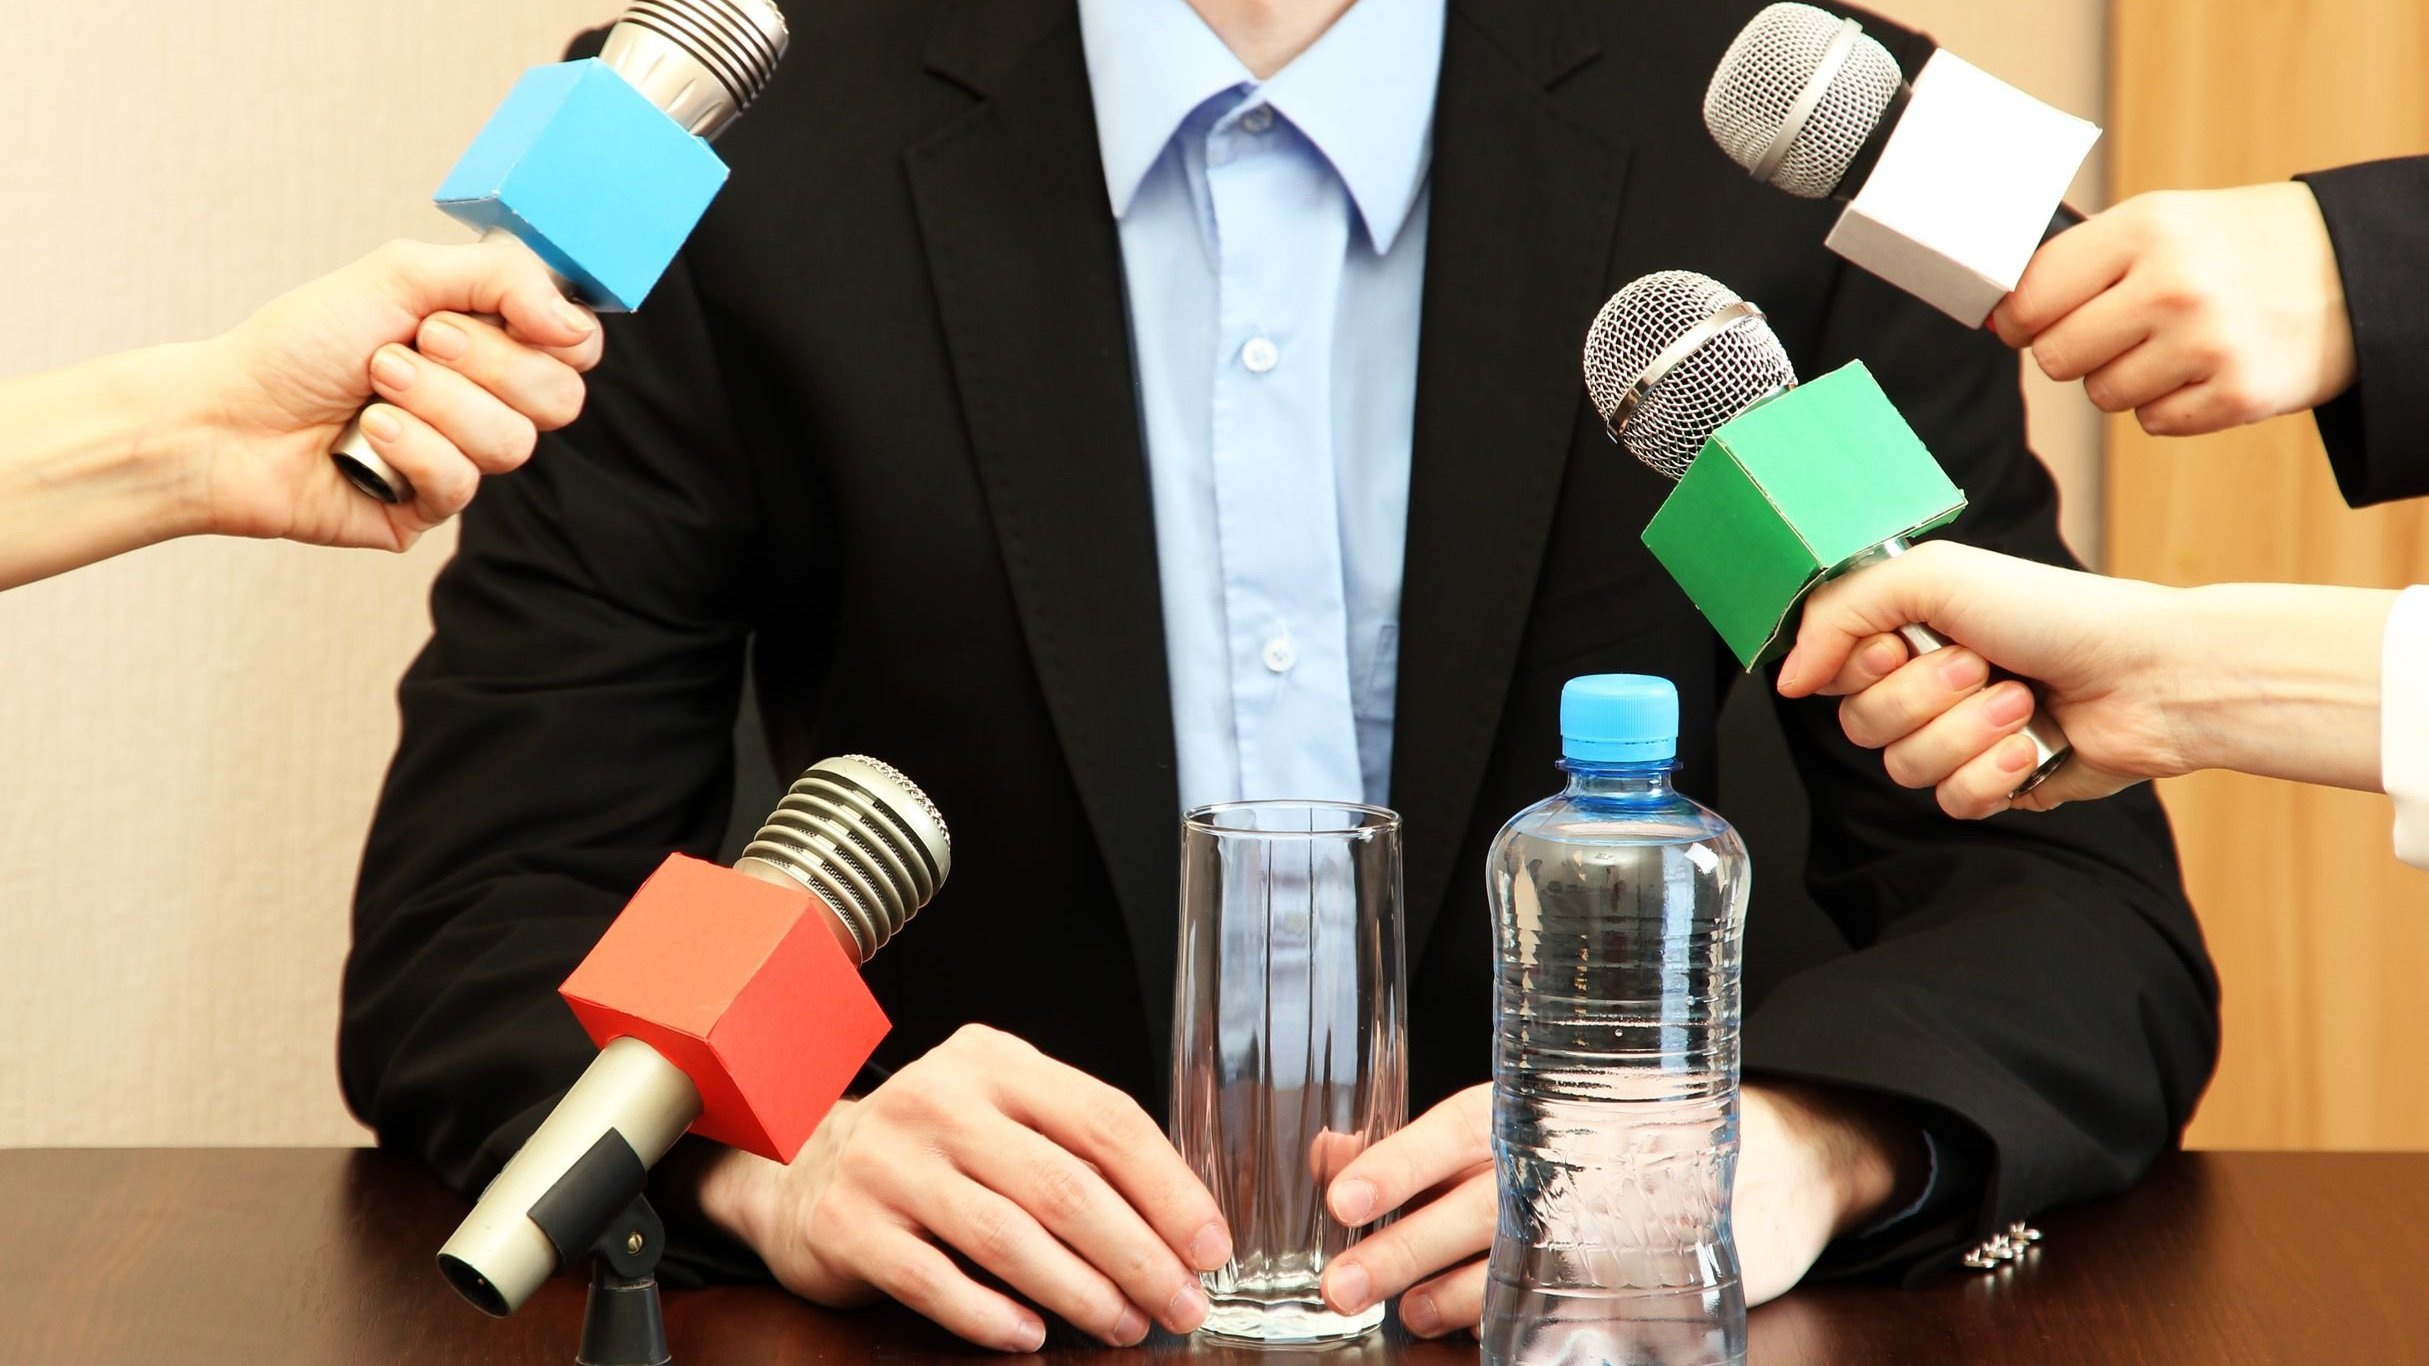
[1584,268,2072,797]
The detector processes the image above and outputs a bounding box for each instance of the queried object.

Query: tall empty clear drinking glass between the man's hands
[1171,802,1409,1344]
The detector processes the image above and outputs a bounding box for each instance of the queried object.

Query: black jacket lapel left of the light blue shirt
[906,0,1180,1072]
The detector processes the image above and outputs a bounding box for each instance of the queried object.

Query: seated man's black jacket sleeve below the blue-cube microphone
[338,252,755,1281]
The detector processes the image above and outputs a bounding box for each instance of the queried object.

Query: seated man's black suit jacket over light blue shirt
[340,0,2218,1266]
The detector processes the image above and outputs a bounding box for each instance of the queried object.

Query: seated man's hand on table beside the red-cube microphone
[700,1026,1232,1351]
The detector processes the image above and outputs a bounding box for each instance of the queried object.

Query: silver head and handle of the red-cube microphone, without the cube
[440,753,952,1317]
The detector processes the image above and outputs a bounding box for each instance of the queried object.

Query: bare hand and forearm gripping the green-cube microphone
[1778,542,2395,819]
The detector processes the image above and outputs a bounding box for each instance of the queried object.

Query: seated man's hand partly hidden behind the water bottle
[1324,1082,1924,1337]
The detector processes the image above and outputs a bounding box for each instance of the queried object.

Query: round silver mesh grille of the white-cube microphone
[1703,5,1904,199]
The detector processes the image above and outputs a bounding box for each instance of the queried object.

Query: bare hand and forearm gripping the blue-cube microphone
[0,243,600,588]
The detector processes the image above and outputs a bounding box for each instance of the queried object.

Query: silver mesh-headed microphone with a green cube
[1586,270,2072,797]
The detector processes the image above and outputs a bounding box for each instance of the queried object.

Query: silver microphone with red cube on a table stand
[440,756,952,1315]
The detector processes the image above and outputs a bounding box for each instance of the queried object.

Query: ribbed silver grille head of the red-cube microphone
[743,753,952,963]
